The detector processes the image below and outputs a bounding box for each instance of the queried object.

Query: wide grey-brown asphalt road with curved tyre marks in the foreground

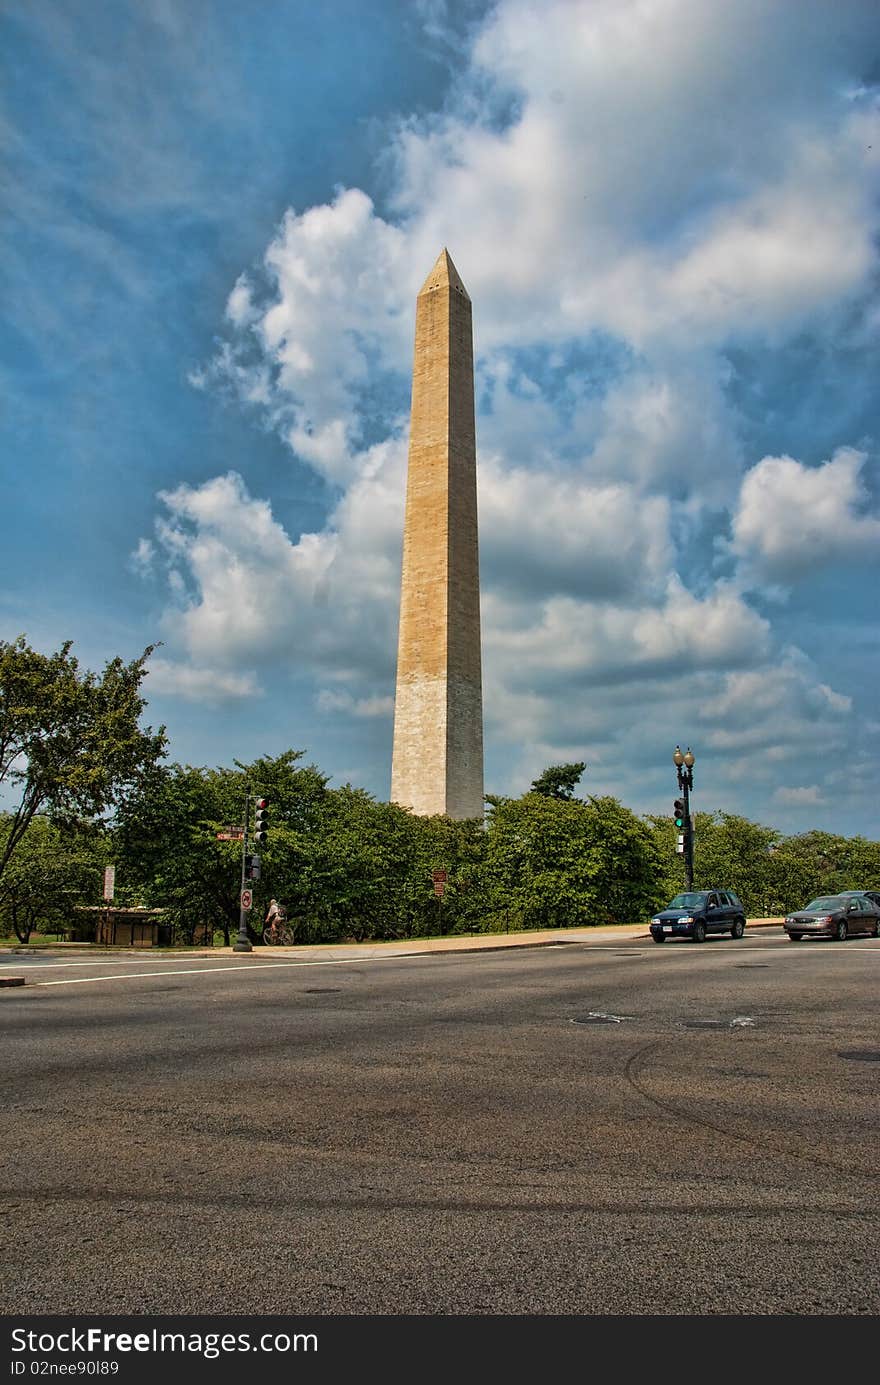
[0,929,880,1314]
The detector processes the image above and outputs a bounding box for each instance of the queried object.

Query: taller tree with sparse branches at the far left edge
[0,636,166,878]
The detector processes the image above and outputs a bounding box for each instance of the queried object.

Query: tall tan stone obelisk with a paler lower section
[391,249,482,819]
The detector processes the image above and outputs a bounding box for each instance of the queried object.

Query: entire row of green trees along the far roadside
[0,637,880,943]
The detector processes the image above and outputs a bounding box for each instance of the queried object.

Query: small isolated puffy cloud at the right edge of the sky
[732,447,880,582]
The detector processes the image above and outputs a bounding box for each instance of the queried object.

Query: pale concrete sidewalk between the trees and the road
[0,918,782,961]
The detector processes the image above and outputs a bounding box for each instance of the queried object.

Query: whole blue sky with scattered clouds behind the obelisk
[0,0,880,838]
